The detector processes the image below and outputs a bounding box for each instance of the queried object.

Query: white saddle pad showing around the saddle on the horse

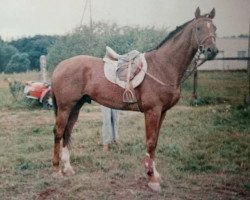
[103,54,148,88]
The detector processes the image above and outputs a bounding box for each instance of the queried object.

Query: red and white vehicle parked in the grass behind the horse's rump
[24,81,53,109]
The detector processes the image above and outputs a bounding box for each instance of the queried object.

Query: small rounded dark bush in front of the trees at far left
[4,53,30,73]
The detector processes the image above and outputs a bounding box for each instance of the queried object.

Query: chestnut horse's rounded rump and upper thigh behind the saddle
[51,55,104,103]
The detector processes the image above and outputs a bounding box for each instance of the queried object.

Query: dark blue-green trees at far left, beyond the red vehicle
[0,35,58,73]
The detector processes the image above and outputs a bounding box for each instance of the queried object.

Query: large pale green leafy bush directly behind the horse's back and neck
[47,23,166,70]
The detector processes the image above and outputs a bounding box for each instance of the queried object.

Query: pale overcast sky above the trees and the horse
[0,0,250,40]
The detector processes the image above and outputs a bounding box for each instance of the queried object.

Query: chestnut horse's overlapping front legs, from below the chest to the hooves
[144,107,166,191]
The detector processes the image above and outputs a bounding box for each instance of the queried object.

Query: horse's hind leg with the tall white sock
[62,109,79,176]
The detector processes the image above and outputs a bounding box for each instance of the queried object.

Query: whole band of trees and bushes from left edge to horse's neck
[0,23,167,73]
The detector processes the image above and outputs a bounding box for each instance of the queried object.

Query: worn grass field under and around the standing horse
[0,72,250,200]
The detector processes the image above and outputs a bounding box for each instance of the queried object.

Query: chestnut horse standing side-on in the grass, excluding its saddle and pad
[52,8,218,191]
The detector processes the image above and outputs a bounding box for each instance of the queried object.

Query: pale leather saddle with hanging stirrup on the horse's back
[104,47,142,103]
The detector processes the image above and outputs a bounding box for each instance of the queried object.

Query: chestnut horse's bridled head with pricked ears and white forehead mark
[193,7,218,60]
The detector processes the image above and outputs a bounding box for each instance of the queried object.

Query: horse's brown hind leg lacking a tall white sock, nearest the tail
[53,109,70,177]
